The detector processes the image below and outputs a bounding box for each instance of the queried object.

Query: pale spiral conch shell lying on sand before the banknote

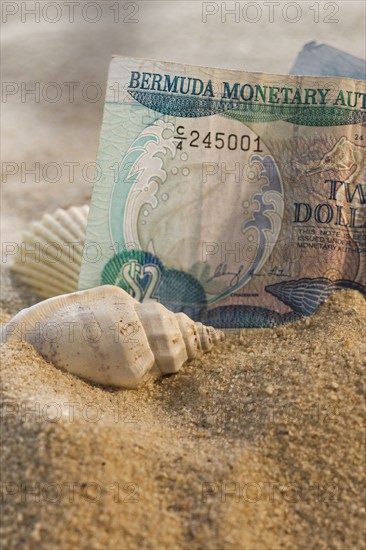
[2,285,223,388]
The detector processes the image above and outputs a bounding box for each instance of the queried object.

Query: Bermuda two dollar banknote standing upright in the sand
[79,56,366,328]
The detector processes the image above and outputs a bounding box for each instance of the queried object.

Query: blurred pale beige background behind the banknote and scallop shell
[1,0,366,241]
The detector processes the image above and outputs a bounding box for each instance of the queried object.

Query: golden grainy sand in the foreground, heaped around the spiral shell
[1,272,366,550]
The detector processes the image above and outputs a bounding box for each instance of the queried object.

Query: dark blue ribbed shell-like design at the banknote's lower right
[265,277,366,316]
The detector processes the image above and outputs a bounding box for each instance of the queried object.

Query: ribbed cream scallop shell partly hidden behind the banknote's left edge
[12,205,89,298]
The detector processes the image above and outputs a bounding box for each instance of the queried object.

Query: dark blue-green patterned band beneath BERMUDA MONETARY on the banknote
[129,90,366,126]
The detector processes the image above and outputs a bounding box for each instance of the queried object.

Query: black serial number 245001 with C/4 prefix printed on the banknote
[174,126,263,153]
